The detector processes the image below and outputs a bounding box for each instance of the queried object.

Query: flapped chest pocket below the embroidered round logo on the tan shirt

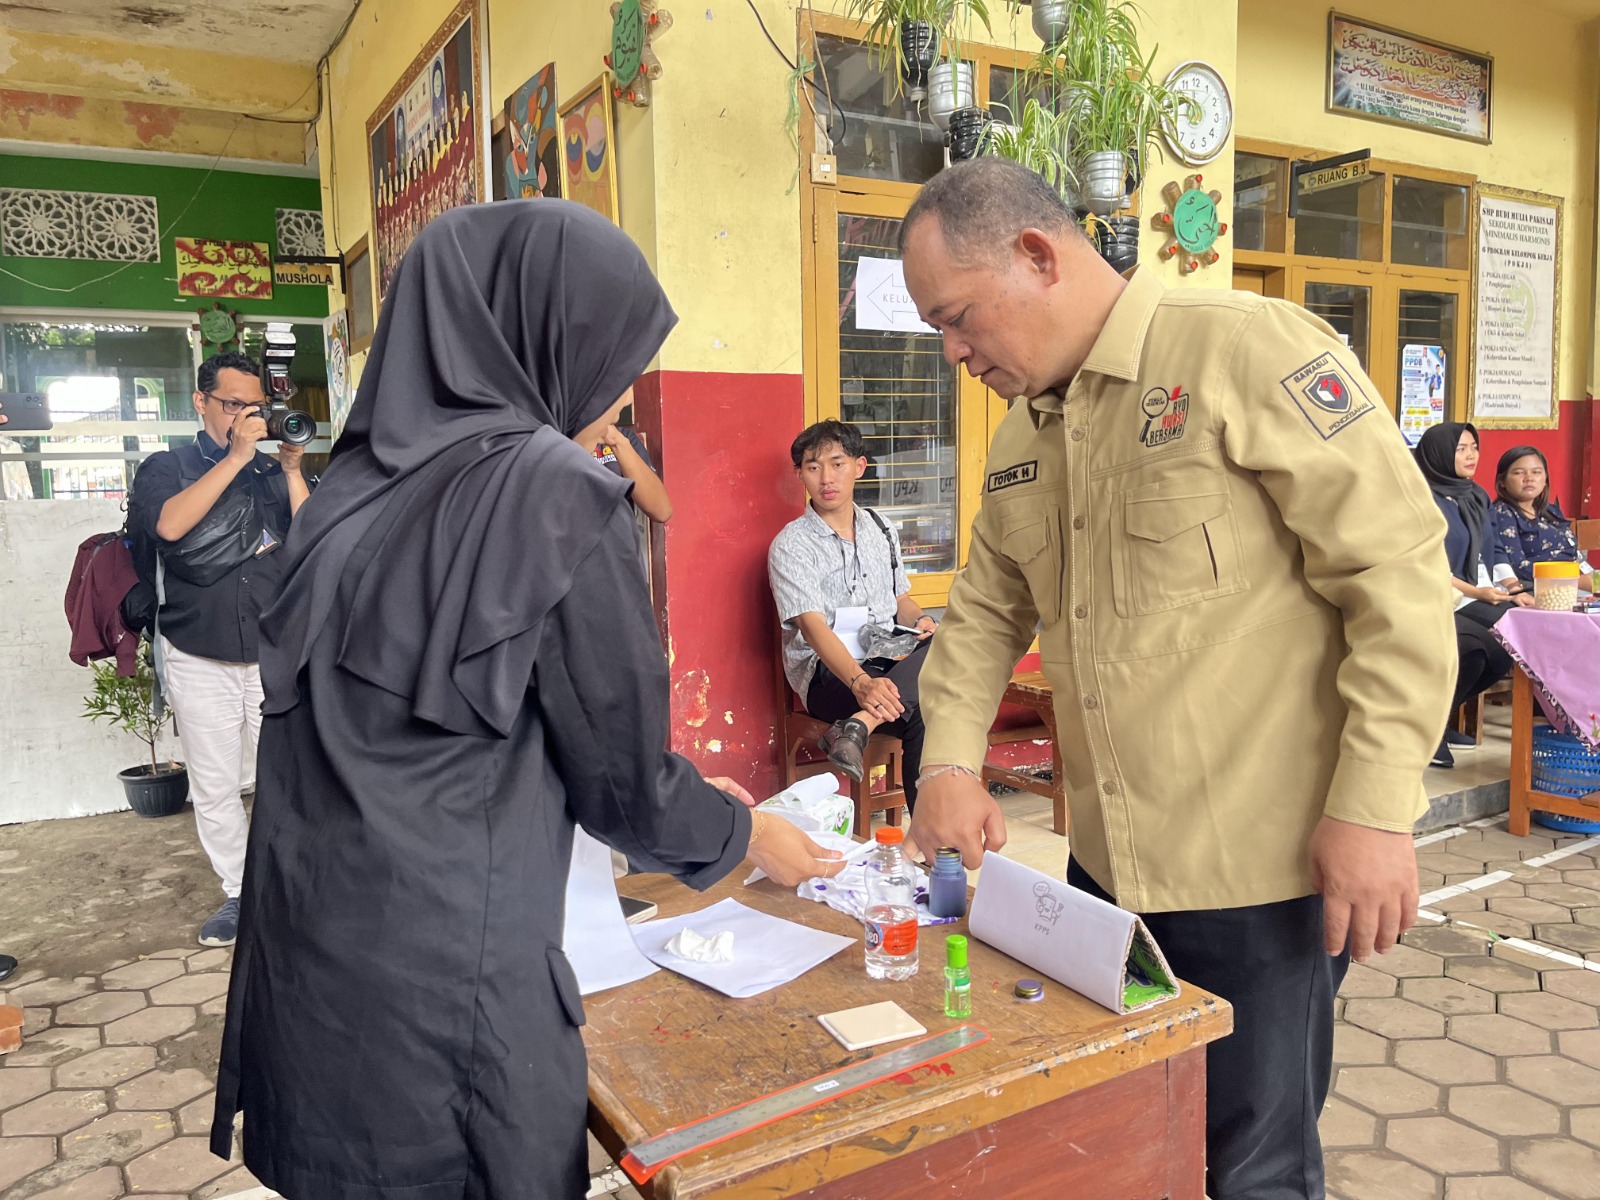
[1110,477,1248,616]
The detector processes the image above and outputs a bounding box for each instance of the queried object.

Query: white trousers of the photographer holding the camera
[162,637,261,896]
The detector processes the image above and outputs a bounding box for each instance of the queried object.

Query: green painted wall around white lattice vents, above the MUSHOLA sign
[0,154,328,317]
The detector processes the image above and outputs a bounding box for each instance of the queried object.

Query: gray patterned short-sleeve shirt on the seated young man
[766,504,910,699]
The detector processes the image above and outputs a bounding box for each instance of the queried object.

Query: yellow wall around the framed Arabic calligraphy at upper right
[1235,0,1600,398]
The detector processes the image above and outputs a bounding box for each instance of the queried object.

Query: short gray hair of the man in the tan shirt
[899,157,1082,261]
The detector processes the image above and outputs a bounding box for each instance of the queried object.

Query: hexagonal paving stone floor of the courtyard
[0,812,1600,1200]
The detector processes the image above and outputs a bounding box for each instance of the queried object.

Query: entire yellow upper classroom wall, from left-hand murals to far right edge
[318,0,1600,395]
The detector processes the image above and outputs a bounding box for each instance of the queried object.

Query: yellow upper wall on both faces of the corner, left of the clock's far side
[318,0,1234,374]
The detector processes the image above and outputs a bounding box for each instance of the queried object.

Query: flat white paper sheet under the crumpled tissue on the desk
[634,899,856,1000]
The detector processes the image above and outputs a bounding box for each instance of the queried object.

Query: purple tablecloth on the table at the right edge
[1494,608,1600,754]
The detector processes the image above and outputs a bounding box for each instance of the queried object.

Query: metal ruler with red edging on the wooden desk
[622,1026,989,1184]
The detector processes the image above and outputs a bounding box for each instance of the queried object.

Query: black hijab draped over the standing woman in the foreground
[261,200,677,736]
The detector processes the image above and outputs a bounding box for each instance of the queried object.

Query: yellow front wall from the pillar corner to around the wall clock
[636,0,1235,373]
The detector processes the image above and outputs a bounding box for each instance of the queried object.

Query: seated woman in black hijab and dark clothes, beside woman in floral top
[1416,422,1533,766]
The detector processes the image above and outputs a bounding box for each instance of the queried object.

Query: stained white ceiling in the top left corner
[0,0,355,66]
